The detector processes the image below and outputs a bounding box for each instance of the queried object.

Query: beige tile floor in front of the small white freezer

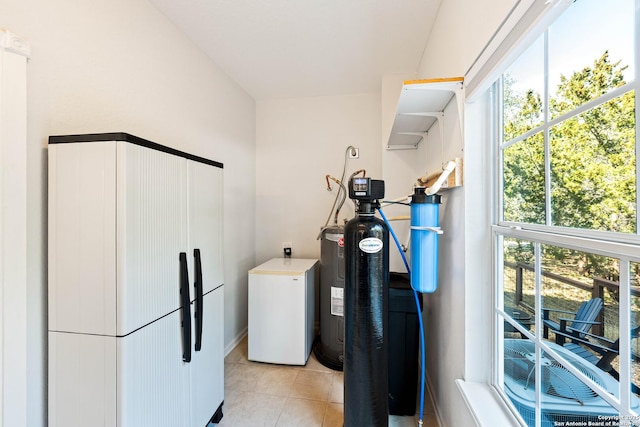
[218,338,438,427]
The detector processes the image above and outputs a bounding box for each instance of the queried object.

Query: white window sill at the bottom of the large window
[456,380,520,427]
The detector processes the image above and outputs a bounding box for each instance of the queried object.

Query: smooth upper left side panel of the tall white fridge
[48,142,116,335]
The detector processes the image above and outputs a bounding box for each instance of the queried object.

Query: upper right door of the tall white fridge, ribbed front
[188,161,224,293]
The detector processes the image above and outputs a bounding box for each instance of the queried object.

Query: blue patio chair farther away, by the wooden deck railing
[542,298,603,339]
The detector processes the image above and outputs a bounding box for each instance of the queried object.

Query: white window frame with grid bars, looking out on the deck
[488,0,640,419]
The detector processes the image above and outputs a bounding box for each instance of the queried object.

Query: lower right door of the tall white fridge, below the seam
[191,286,224,427]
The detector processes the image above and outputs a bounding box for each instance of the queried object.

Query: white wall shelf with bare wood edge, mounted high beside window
[387,77,463,150]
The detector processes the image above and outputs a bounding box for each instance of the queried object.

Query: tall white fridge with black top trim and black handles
[48,133,224,427]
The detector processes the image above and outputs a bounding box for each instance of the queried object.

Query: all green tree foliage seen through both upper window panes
[503,52,636,278]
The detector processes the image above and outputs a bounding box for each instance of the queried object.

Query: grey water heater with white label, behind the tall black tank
[313,225,344,371]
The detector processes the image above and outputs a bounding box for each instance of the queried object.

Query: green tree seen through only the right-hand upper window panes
[549,52,636,233]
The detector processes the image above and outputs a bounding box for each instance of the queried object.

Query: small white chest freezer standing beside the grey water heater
[248,258,318,365]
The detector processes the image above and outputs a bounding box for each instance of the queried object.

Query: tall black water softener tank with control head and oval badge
[344,178,389,427]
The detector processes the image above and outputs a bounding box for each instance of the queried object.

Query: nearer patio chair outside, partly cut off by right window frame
[556,326,640,394]
